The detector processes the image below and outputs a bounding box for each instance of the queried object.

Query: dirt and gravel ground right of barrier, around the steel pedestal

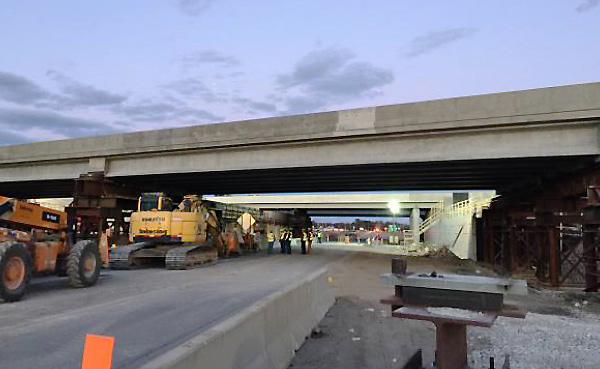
[290,247,600,369]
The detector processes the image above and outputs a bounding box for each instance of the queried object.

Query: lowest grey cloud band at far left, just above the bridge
[0,108,118,141]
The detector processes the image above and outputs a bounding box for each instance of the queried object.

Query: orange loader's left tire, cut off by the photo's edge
[0,241,31,302]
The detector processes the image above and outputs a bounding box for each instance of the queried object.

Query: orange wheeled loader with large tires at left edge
[0,196,102,302]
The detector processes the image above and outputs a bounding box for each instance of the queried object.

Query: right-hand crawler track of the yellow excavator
[165,242,218,270]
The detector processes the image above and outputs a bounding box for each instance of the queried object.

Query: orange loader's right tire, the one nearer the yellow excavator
[67,240,102,288]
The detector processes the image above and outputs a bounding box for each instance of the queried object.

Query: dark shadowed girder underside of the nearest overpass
[0,156,596,198]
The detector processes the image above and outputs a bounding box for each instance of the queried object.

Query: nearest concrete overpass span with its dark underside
[0,83,600,197]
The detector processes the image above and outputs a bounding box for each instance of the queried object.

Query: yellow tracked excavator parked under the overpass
[109,192,225,269]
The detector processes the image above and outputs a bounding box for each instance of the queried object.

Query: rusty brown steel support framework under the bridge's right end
[483,170,600,291]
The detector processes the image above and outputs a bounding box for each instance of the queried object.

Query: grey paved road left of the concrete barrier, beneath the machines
[0,250,345,369]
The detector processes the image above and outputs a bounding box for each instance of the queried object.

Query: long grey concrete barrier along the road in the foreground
[142,268,335,369]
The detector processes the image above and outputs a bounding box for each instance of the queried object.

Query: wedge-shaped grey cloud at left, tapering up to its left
[46,70,127,107]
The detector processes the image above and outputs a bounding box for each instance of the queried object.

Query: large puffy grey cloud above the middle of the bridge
[277,48,394,113]
